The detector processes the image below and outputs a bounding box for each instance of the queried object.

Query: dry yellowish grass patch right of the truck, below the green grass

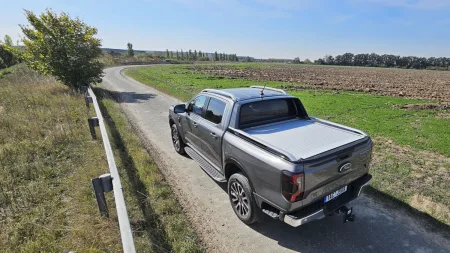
[371,138,450,224]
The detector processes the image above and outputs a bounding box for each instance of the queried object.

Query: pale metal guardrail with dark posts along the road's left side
[86,86,136,253]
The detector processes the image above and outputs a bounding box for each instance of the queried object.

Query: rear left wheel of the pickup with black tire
[228,173,258,225]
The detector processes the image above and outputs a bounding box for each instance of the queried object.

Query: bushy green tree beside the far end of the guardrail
[15,9,103,89]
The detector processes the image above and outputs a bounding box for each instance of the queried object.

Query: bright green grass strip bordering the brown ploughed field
[126,64,450,156]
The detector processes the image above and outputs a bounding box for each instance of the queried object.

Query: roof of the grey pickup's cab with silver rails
[202,86,287,101]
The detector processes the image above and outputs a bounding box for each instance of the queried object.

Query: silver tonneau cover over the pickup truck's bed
[242,119,366,160]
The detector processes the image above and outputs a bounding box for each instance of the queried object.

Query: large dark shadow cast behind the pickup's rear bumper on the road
[250,193,446,253]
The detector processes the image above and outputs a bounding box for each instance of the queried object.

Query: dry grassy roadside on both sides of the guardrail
[0,65,201,252]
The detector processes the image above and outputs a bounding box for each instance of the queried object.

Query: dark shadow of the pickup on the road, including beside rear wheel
[209,175,450,253]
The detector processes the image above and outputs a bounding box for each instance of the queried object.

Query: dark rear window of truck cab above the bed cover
[239,99,297,128]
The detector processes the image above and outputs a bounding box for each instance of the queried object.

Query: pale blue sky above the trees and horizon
[0,0,450,59]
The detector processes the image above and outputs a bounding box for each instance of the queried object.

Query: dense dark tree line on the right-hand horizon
[315,53,450,70]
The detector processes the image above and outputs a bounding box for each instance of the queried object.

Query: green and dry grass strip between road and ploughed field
[125,65,450,224]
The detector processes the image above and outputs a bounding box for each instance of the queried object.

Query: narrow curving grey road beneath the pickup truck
[102,67,450,253]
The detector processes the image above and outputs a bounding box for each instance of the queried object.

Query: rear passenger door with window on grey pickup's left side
[198,97,227,168]
